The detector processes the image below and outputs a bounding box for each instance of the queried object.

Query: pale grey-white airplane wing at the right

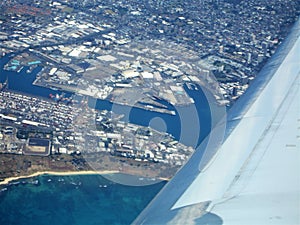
[133,20,300,225]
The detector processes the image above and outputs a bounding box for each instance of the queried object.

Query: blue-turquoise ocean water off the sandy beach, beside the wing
[0,175,166,225]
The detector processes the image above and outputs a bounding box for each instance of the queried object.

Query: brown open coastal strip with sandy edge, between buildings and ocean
[0,154,171,186]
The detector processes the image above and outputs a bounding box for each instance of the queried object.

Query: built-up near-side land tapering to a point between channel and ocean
[0,90,193,181]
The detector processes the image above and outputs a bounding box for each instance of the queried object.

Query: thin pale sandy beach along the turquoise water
[0,170,119,185]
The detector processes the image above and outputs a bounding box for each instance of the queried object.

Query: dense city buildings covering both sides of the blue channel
[0,0,300,178]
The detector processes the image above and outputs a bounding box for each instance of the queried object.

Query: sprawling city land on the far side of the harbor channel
[0,0,300,105]
